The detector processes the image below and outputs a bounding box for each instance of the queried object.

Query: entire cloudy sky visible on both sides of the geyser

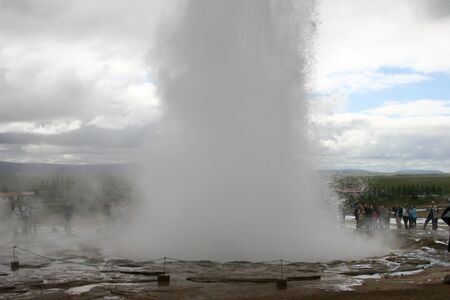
[0,0,450,171]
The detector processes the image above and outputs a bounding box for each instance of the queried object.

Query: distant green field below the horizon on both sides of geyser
[0,170,450,210]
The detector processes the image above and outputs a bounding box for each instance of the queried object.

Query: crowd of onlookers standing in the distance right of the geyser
[353,201,439,230]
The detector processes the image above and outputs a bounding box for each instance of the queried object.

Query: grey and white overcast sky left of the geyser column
[0,0,172,163]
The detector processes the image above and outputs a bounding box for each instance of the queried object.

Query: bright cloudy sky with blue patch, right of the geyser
[314,0,450,171]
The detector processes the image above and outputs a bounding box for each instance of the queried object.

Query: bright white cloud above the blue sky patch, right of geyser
[314,0,450,92]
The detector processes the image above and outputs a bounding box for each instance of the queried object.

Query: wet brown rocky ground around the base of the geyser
[0,219,450,299]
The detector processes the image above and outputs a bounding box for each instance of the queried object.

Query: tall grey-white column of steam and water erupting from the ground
[122,0,386,261]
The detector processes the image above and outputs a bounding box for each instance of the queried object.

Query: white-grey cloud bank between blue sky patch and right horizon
[314,100,450,171]
